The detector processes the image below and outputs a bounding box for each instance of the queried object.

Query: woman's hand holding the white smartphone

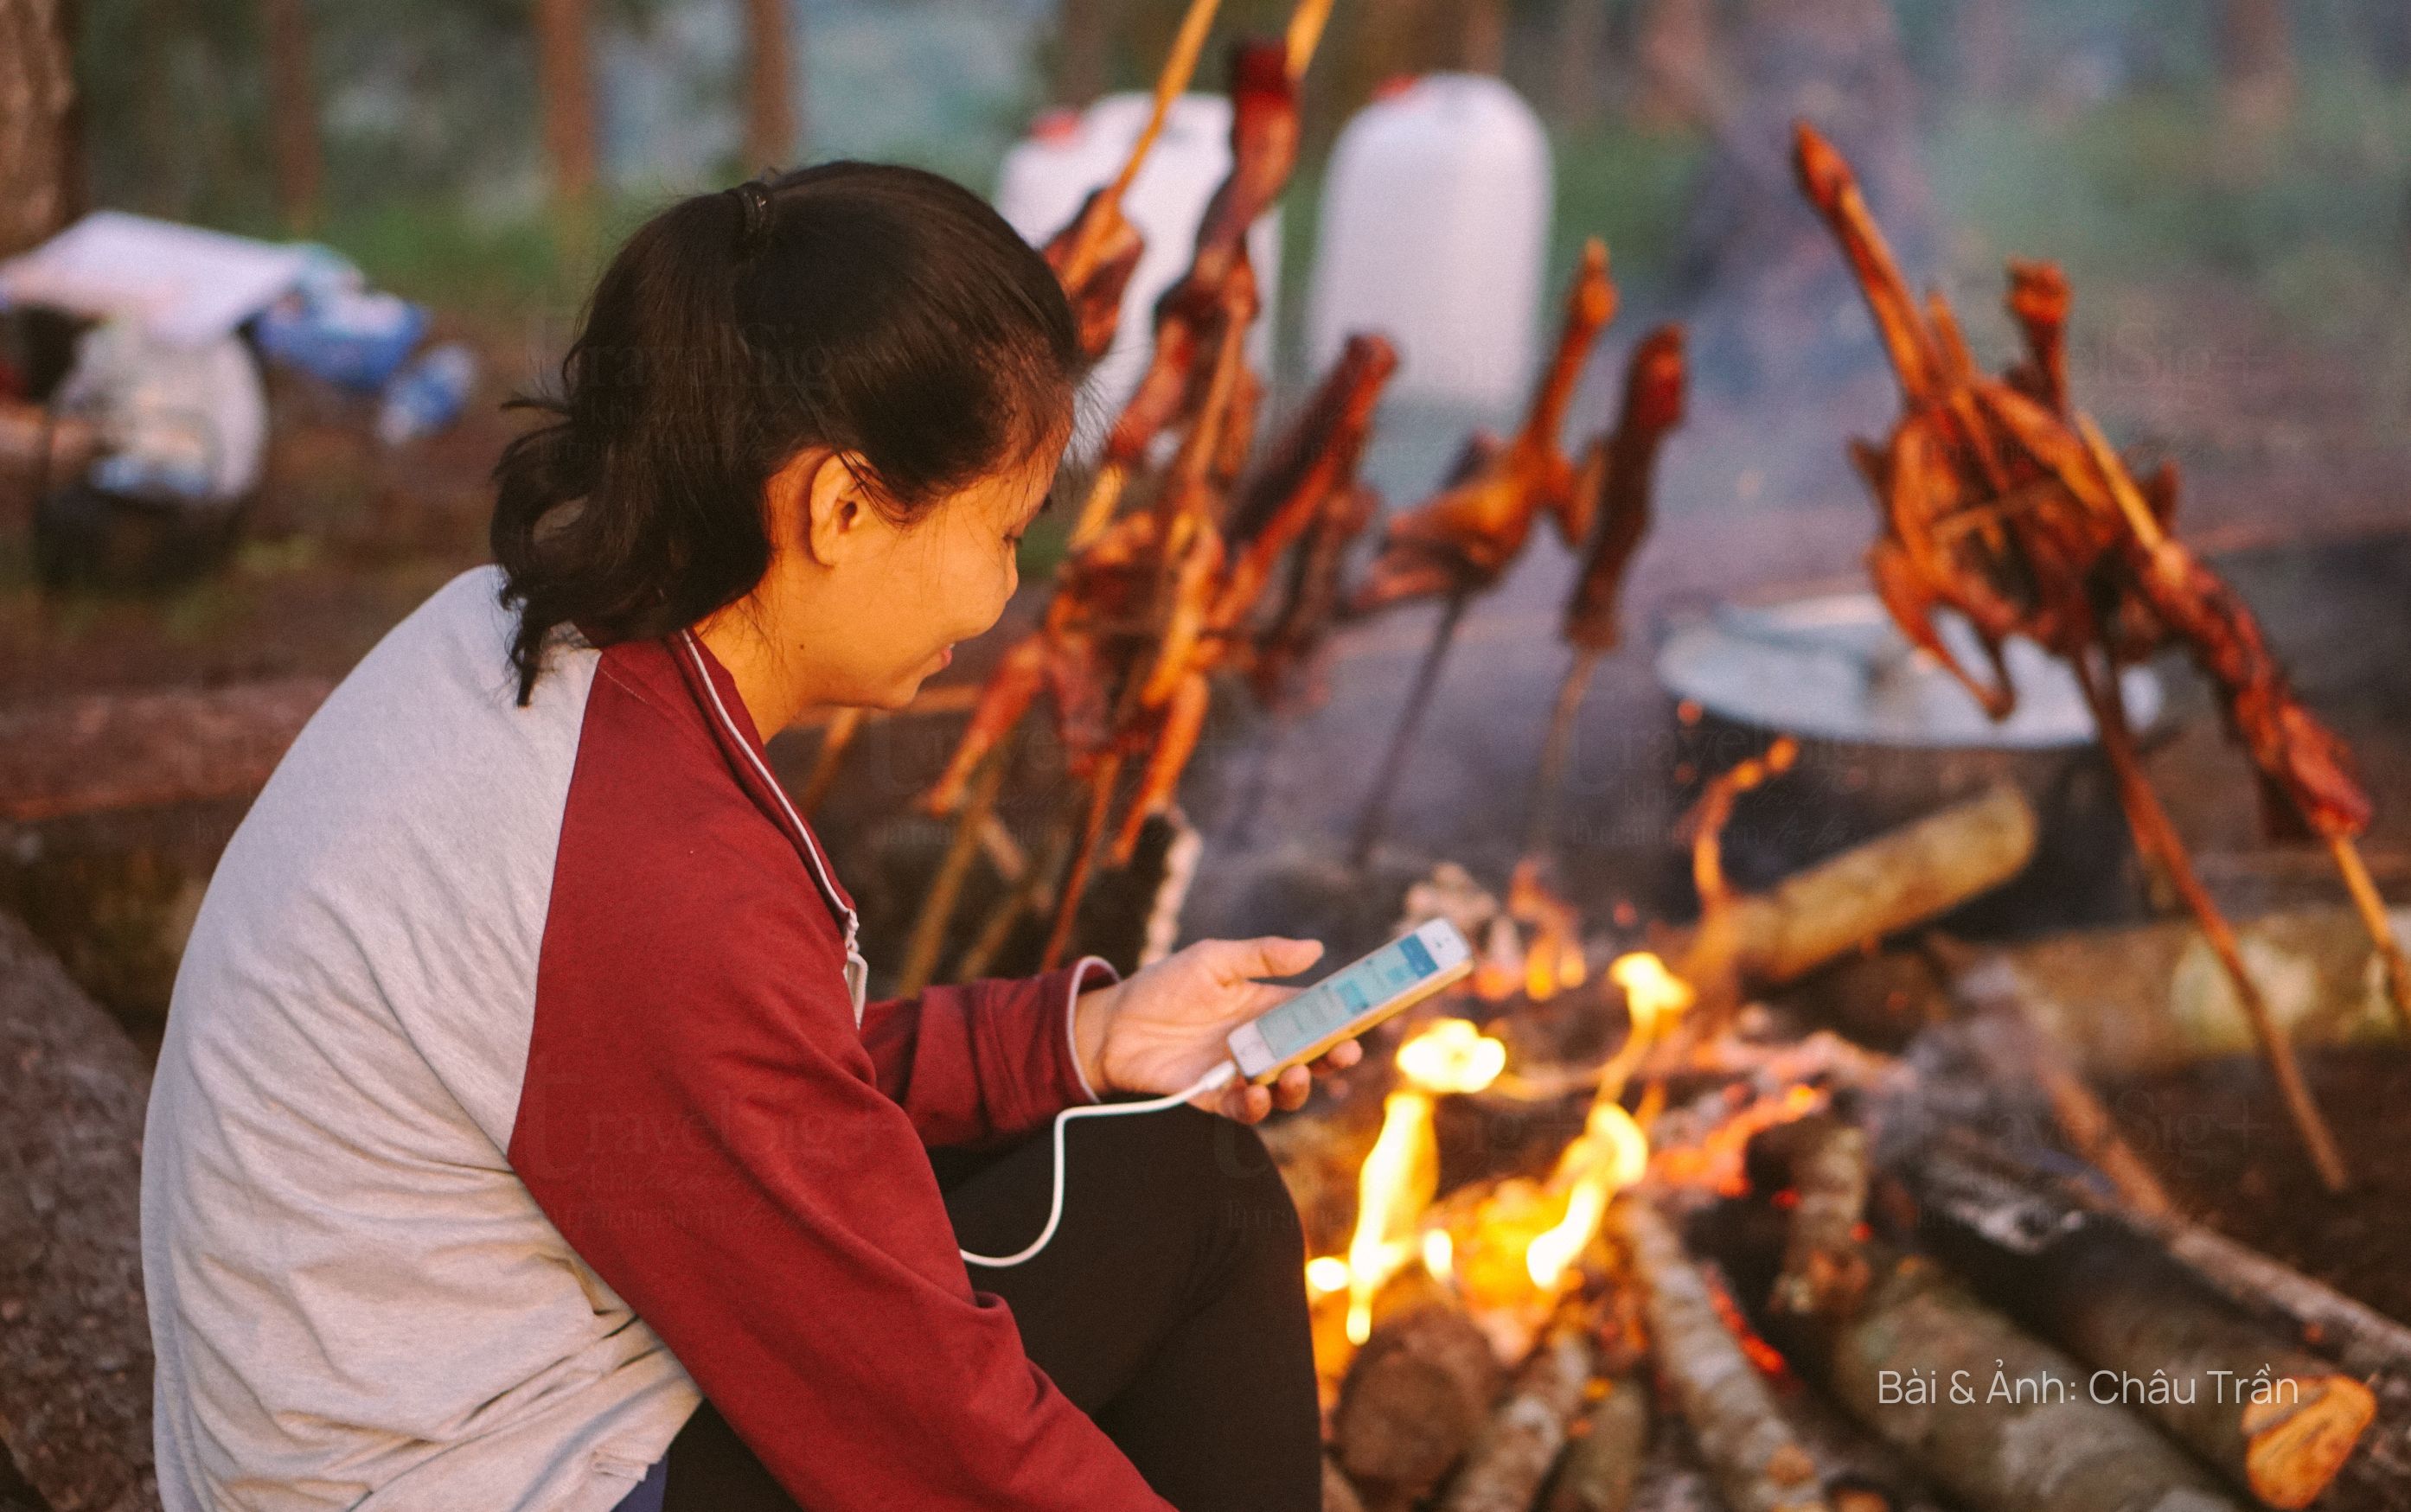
[1073,935,1365,1124]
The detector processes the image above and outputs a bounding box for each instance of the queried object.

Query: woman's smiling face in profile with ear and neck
[750,437,1065,718]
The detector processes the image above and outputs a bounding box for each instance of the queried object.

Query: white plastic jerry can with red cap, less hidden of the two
[1307,73,1552,412]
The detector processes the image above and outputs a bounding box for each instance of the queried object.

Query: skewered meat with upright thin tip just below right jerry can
[1347,239,1615,615]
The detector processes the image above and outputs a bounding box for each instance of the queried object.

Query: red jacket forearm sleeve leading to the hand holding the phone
[863,955,1114,1145]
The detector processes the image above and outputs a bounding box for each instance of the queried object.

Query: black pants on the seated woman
[663,1107,1321,1512]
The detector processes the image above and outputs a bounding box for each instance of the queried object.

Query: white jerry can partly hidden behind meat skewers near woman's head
[995,92,1280,426]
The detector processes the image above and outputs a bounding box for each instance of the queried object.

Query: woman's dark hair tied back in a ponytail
[492,162,1083,702]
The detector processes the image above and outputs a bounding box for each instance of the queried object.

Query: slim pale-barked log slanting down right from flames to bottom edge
[1610,1196,1827,1512]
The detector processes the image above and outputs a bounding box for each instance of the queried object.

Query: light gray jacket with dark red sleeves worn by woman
[142,569,1165,1512]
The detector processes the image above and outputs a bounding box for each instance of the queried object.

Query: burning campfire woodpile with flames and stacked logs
[1270,796,2411,1512]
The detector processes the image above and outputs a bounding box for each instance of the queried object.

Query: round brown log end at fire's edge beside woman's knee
[1331,1298,1505,1512]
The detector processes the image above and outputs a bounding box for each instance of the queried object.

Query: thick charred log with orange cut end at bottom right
[1909,1148,2377,1509]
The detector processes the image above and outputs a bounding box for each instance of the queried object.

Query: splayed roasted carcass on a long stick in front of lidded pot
[1796,125,2349,1191]
